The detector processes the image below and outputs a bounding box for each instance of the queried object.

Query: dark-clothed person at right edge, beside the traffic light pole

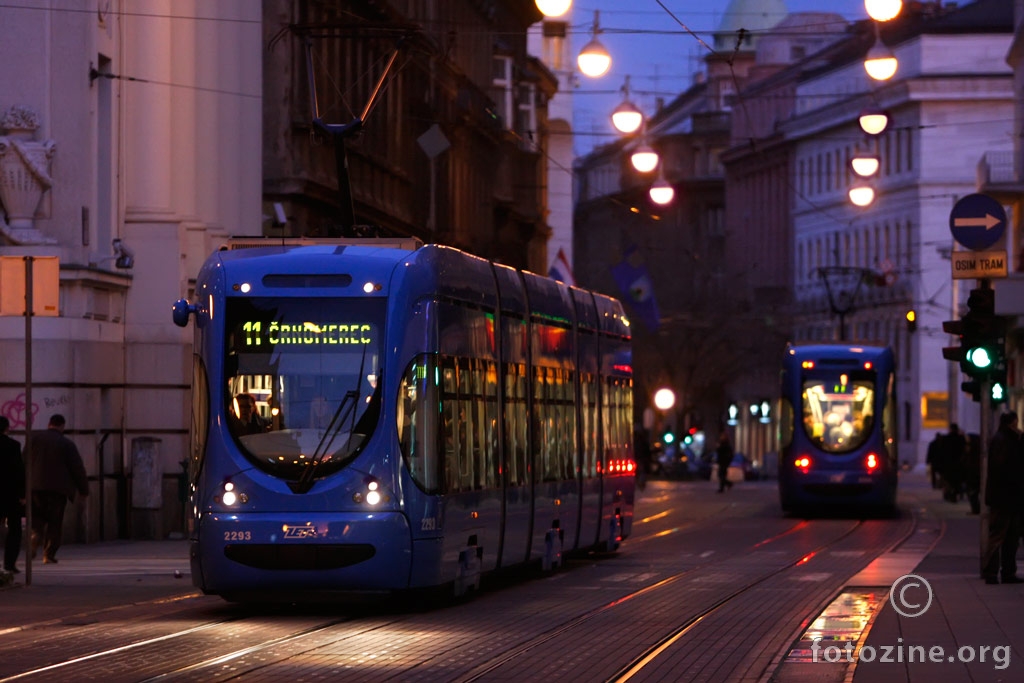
[983,413,1024,584]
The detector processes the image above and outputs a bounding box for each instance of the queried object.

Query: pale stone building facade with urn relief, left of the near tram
[0,0,262,540]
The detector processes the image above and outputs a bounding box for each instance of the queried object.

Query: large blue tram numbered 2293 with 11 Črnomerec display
[173,240,635,600]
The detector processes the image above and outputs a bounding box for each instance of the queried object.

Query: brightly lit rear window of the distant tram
[802,373,874,453]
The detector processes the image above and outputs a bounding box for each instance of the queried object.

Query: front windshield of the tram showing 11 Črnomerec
[223,297,384,480]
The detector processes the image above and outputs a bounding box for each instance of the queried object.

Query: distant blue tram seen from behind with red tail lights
[778,344,899,514]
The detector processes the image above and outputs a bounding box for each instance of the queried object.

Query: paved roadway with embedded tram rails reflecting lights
[0,481,929,683]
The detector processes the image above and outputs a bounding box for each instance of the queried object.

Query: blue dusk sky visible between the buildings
[571,0,867,155]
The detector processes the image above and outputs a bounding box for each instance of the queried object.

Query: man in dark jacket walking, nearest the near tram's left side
[30,414,89,564]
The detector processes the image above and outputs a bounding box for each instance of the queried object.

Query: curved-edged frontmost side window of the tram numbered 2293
[397,355,439,493]
